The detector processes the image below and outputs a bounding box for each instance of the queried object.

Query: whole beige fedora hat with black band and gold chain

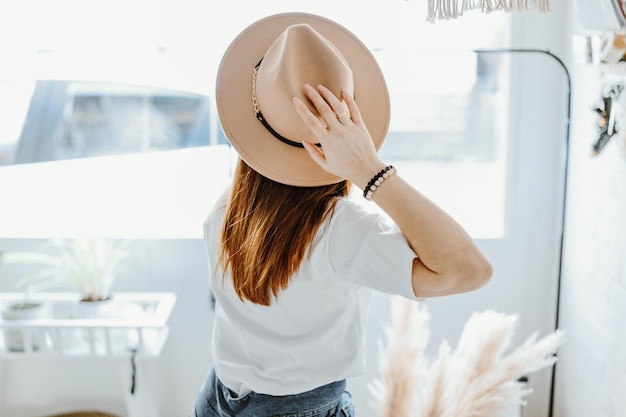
[216,13,390,187]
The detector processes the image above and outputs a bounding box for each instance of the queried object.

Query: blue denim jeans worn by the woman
[191,369,354,417]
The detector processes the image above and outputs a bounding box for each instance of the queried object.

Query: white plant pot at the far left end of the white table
[2,301,46,352]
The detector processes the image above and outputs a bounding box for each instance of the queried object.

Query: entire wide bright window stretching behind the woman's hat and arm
[0,0,509,238]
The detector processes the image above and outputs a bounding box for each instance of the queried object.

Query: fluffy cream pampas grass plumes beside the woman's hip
[372,297,564,417]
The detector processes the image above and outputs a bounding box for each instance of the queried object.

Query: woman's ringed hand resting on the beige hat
[293,84,385,189]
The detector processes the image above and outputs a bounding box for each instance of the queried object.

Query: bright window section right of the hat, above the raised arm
[370,50,509,238]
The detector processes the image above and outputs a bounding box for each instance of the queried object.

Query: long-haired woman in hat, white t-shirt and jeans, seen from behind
[194,13,491,417]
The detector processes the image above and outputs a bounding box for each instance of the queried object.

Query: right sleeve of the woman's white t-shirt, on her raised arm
[328,201,417,299]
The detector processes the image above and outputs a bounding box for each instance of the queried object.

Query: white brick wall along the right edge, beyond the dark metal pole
[554,13,626,417]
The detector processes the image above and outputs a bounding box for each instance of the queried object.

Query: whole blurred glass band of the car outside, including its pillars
[0,80,227,165]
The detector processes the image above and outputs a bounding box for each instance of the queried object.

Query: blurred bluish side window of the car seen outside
[62,83,209,157]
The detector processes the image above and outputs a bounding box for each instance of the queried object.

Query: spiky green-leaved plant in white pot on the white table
[0,238,129,317]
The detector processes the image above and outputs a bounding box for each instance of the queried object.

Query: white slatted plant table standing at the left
[0,293,176,359]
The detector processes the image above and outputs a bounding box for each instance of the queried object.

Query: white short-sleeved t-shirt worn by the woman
[204,195,416,395]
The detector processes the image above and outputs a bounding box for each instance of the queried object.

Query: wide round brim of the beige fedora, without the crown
[216,13,390,187]
